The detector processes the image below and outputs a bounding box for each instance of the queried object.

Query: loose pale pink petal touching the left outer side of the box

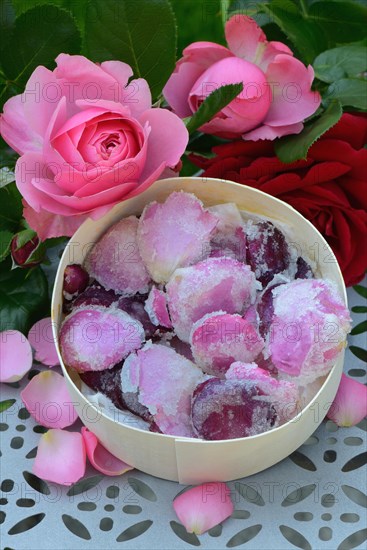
[28,317,60,367]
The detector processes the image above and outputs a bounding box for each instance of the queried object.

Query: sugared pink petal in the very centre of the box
[166,257,257,342]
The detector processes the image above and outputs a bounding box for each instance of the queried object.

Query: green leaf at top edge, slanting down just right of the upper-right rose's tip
[262,0,328,63]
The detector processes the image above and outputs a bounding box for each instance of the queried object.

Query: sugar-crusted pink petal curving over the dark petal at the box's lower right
[225,361,299,424]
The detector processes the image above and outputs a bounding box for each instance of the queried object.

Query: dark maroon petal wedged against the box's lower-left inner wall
[79,362,127,410]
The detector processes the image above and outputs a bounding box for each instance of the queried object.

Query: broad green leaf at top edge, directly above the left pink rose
[85,0,176,98]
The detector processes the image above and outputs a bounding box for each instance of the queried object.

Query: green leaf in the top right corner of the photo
[308,0,367,45]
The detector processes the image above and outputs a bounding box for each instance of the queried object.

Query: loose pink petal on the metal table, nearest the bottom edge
[173,482,233,535]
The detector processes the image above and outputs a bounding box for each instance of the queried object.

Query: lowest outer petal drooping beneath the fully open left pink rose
[23,200,88,241]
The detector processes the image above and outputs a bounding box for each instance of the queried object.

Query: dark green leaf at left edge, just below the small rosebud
[0,261,49,334]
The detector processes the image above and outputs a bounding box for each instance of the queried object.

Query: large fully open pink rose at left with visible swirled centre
[0,54,188,239]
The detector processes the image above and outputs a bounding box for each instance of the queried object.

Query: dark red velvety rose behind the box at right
[191,113,367,286]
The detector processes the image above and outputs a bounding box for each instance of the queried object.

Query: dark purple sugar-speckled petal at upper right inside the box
[246,221,290,286]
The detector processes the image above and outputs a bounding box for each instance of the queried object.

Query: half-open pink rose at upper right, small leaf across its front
[163,15,321,140]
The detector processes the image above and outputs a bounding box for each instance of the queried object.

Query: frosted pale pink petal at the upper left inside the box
[86,216,150,296]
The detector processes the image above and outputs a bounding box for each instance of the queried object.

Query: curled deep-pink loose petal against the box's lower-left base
[82,427,133,476]
